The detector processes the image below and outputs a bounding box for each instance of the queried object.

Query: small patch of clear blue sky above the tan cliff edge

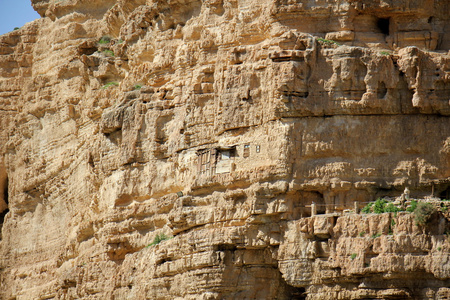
[0,0,40,35]
